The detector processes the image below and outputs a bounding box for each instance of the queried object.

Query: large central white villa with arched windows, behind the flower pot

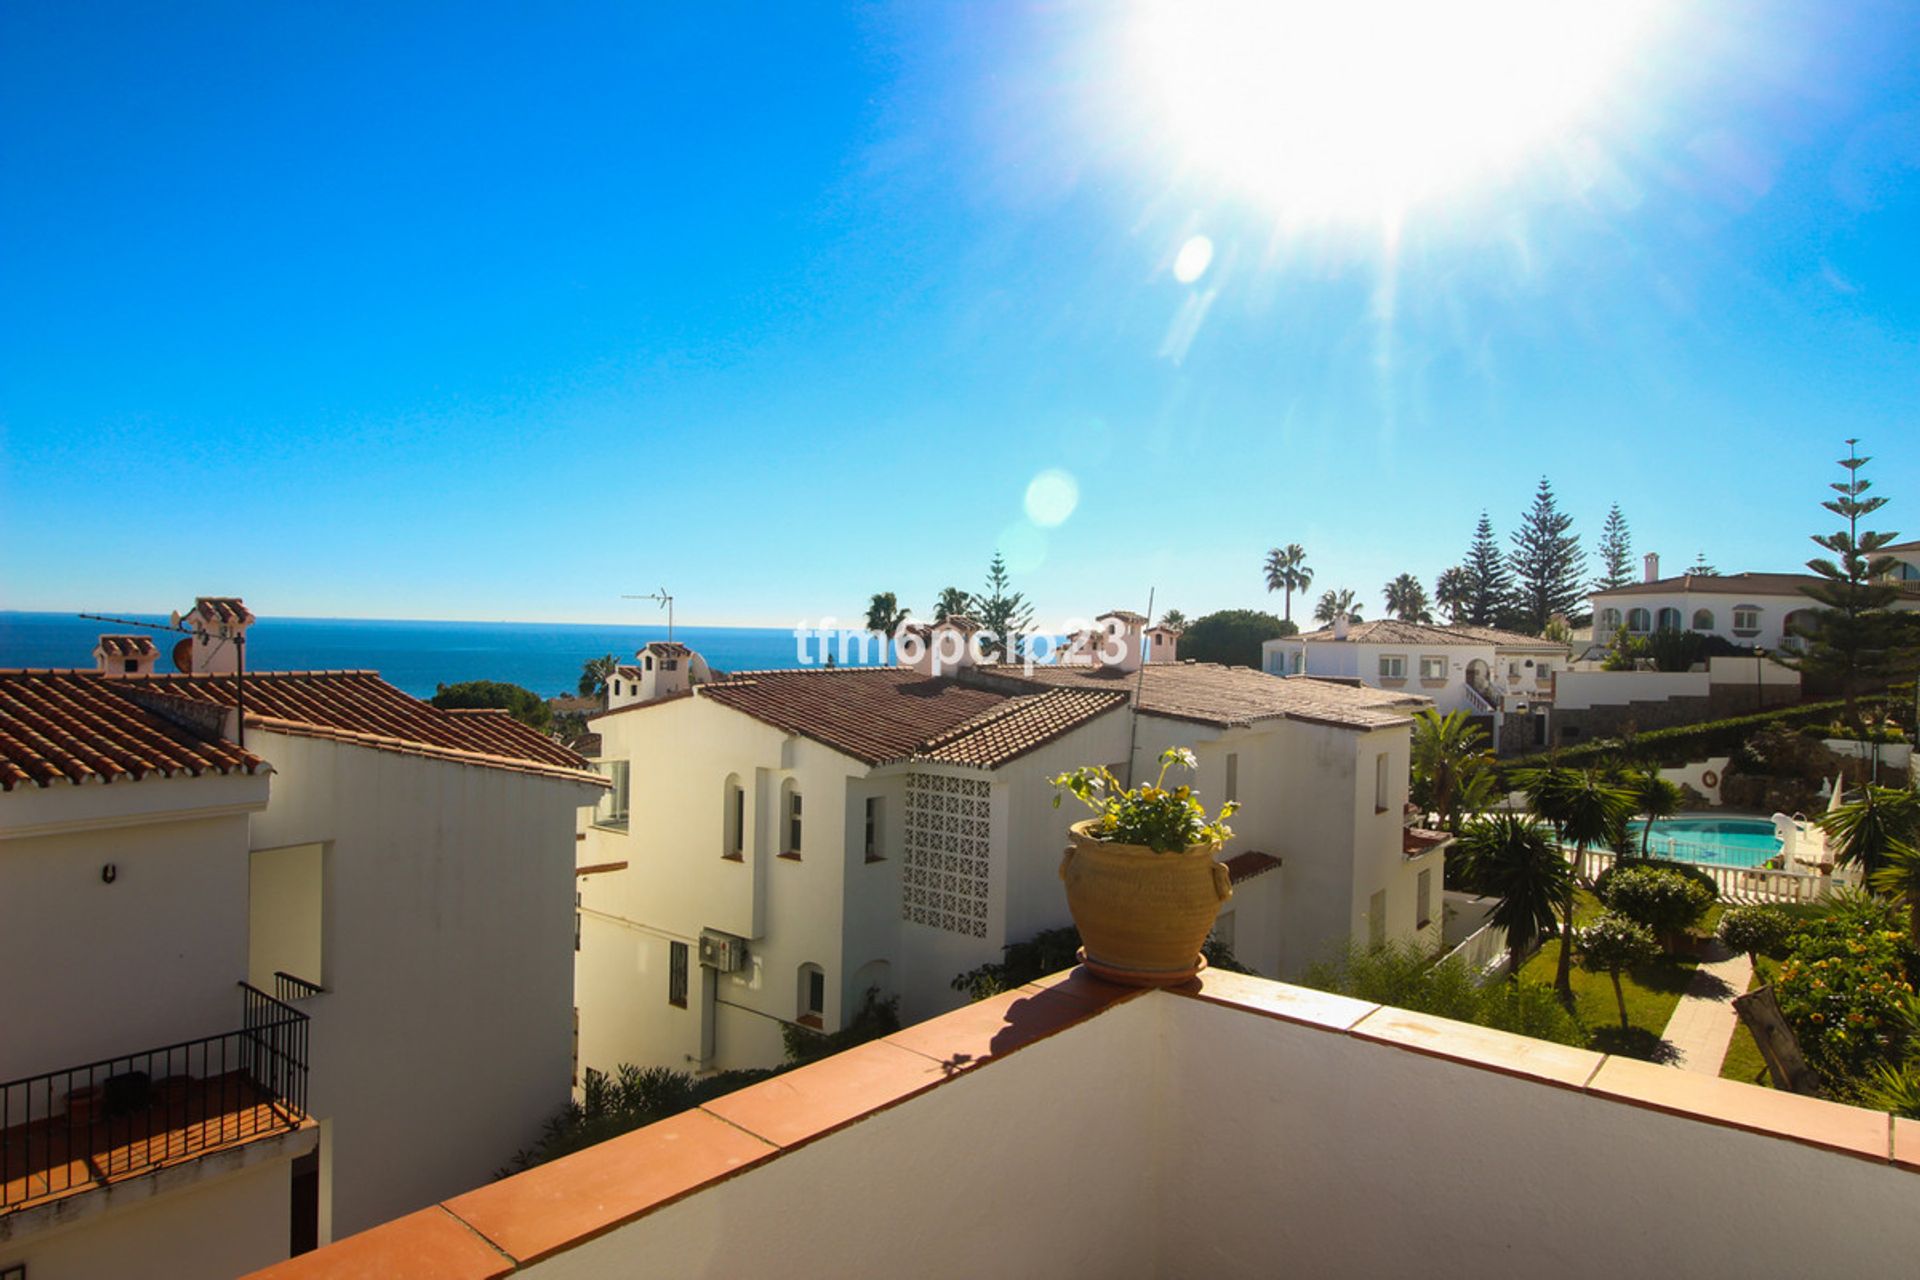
[576,614,1442,1071]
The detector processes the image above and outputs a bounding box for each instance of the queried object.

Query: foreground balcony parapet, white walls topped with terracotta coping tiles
[261,971,1920,1280]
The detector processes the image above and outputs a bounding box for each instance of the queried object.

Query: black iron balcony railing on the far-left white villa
[0,979,307,1217]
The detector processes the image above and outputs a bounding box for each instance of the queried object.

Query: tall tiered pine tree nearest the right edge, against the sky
[1780,439,1899,737]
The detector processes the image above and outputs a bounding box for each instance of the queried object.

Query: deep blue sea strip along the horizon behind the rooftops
[0,610,879,699]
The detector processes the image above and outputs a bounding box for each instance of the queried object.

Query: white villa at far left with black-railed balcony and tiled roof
[0,597,605,1280]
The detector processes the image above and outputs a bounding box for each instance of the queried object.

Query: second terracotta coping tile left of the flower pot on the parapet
[705,1040,948,1148]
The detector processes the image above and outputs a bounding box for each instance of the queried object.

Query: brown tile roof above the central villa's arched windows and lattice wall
[622,666,1125,770]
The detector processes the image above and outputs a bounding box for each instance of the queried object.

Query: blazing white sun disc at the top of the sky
[1127,0,1653,223]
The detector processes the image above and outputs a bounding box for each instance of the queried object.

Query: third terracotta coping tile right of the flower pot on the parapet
[1588,1057,1891,1161]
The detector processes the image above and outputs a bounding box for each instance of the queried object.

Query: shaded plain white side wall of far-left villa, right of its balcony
[247,731,593,1236]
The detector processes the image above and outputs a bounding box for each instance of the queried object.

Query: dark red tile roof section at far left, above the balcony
[0,672,265,791]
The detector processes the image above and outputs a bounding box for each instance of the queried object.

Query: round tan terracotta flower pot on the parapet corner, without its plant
[1060,819,1233,986]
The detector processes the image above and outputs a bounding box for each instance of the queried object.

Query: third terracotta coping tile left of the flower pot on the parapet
[445,1109,778,1263]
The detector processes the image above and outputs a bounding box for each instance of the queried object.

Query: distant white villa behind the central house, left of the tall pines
[1261,618,1567,750]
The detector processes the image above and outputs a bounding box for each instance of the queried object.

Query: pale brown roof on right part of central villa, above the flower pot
[968,662,1430,729]
